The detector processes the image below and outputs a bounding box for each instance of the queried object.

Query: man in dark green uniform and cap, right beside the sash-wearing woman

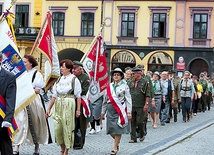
[128,67,150,143]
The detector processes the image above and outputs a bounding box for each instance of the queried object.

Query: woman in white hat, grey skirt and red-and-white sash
[101,68,132,155]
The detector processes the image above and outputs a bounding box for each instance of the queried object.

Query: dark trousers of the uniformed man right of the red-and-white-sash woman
[131,107,147,141]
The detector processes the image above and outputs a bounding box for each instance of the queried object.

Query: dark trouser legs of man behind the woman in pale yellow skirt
[73,118,82,150]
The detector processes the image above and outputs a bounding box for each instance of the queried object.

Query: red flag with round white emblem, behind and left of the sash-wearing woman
[82,35,108,103]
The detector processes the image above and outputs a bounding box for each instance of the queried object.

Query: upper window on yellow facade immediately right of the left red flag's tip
[52,12,65,36]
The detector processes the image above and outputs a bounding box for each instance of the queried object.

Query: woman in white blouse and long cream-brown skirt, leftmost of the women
[13,55,51,155]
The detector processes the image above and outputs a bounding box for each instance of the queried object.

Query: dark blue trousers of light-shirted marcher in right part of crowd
[181,97,191,121]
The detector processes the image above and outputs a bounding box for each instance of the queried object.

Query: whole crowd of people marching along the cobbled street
[0,52,214,155]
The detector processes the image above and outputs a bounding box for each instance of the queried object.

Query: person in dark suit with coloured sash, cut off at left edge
[0,49,17,155]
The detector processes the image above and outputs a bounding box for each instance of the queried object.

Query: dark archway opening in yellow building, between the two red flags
[58,48,84,61]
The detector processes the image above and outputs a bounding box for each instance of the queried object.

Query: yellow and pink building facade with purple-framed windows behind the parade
[0,0,214,77]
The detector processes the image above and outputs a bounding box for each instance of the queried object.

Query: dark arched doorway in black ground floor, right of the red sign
[189,59,209,76]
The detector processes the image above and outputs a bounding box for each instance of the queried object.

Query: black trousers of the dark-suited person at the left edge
[0,117,13,155]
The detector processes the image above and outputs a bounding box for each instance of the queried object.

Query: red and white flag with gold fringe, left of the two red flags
[37,11,60,90]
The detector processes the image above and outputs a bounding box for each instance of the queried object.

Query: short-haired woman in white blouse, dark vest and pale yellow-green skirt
[46,59,82,155]
